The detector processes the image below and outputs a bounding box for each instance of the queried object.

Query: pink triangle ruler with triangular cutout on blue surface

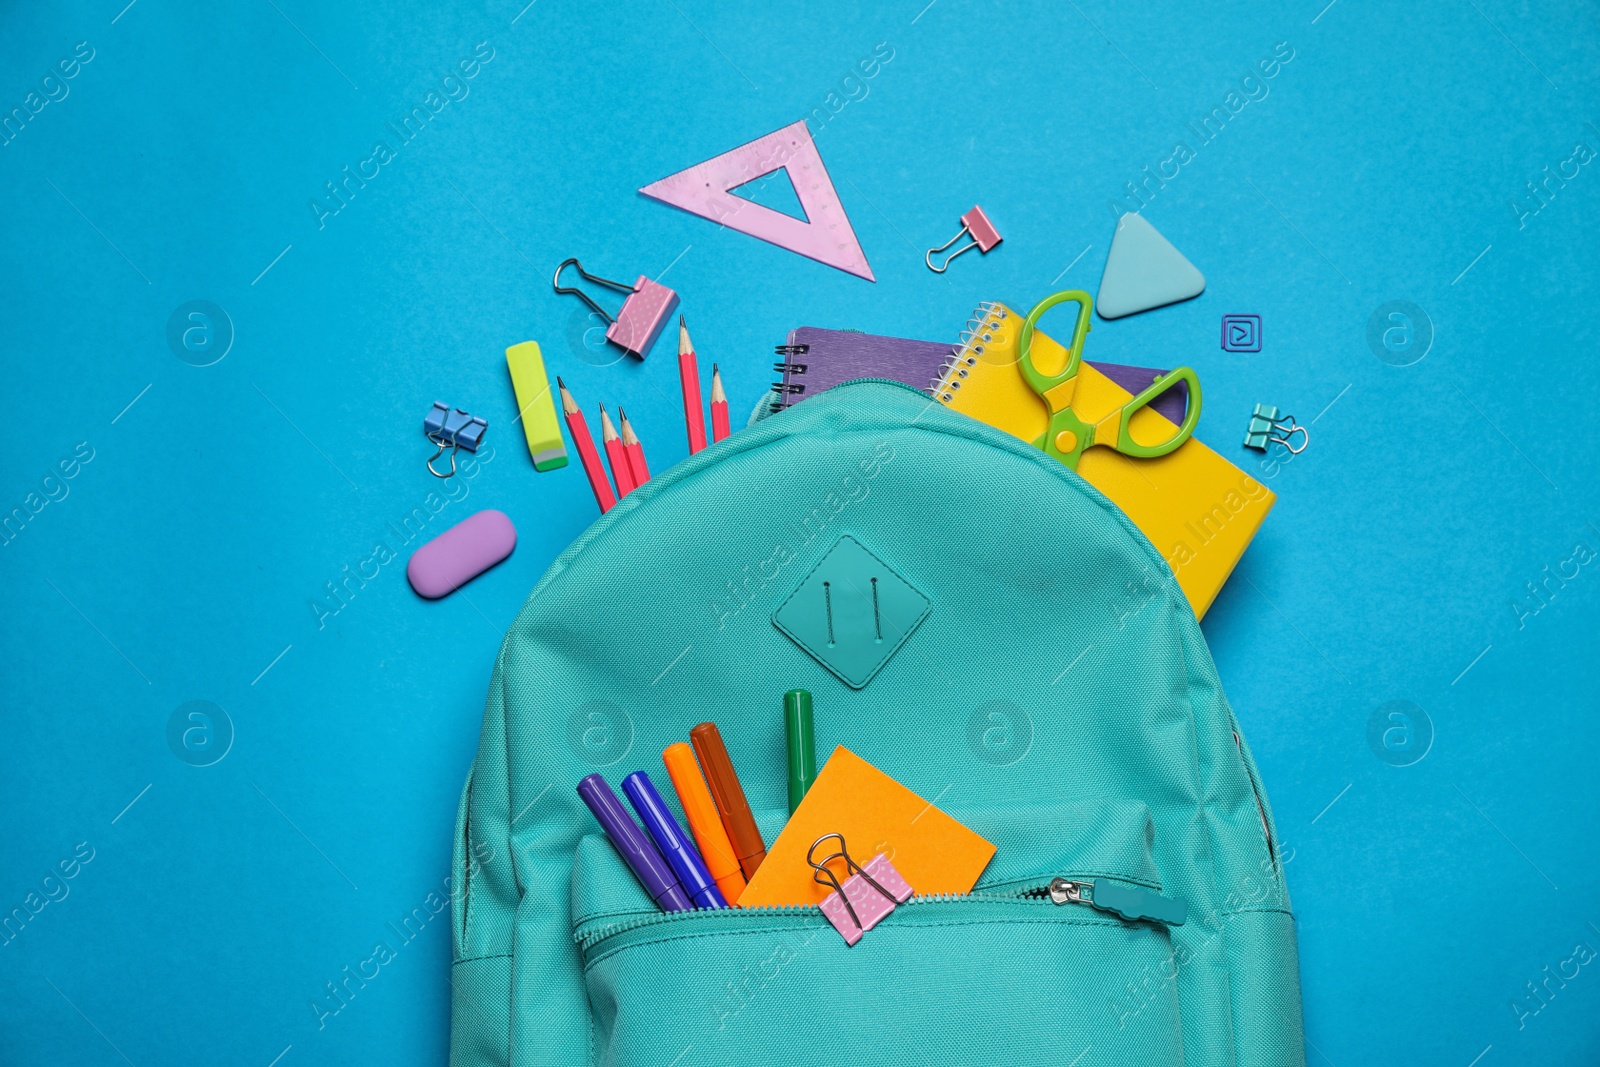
[638,118,877,282]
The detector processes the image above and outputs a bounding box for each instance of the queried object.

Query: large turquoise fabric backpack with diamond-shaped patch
[451,381,1306,1067]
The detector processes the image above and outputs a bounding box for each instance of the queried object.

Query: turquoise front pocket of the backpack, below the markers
[573,801,1182,1067]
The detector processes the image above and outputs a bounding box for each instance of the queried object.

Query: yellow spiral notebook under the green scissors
[934,304,1277,617]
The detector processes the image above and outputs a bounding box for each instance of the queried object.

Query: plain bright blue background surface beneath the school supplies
[0,0,1600,1067]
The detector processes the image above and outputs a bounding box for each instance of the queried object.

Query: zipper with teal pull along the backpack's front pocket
[573,878,1187,952]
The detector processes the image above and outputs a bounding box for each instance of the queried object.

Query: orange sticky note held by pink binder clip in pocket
[739,745,995,907]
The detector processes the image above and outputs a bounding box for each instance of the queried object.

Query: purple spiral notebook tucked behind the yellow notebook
[773,326,1189,422]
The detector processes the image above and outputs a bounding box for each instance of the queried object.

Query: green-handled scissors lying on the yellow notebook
[1018,290,1200,470]
